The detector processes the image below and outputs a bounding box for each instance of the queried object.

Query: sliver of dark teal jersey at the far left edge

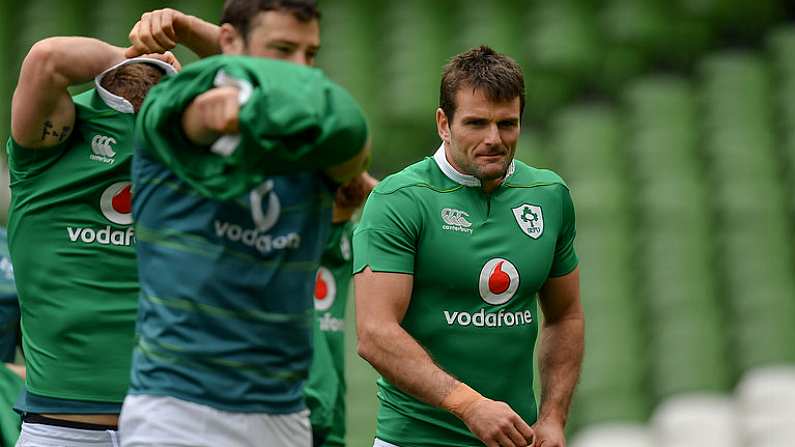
[0,228,19,363]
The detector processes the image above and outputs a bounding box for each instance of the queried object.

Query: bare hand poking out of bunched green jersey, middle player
[182,87,240,145]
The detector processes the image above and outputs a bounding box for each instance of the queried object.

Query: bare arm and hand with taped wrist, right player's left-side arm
[354,267,533,447]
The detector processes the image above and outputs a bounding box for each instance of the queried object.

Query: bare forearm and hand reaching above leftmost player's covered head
[126,8,221,58]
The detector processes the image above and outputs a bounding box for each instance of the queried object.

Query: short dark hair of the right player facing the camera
[439,45,525,121]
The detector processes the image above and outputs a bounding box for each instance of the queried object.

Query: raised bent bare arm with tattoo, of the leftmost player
[11,37,124,148]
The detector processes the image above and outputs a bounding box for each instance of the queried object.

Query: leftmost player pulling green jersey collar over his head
[8,37,177,447]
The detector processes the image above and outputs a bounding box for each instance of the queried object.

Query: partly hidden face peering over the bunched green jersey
[243,11,320,65]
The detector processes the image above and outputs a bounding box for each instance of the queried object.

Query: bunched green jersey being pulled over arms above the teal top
[136,56,368,199]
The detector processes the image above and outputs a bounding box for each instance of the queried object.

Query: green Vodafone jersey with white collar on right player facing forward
[353,148,578,447]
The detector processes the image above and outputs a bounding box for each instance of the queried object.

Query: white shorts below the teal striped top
[119,395,312,447]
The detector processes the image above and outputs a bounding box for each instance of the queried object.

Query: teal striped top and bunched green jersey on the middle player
[130,56,367,414]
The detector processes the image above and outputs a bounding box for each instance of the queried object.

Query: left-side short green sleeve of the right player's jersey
[353,187,421,274]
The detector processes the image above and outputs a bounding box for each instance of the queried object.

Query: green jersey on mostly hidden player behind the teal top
[304,221,353,447]
